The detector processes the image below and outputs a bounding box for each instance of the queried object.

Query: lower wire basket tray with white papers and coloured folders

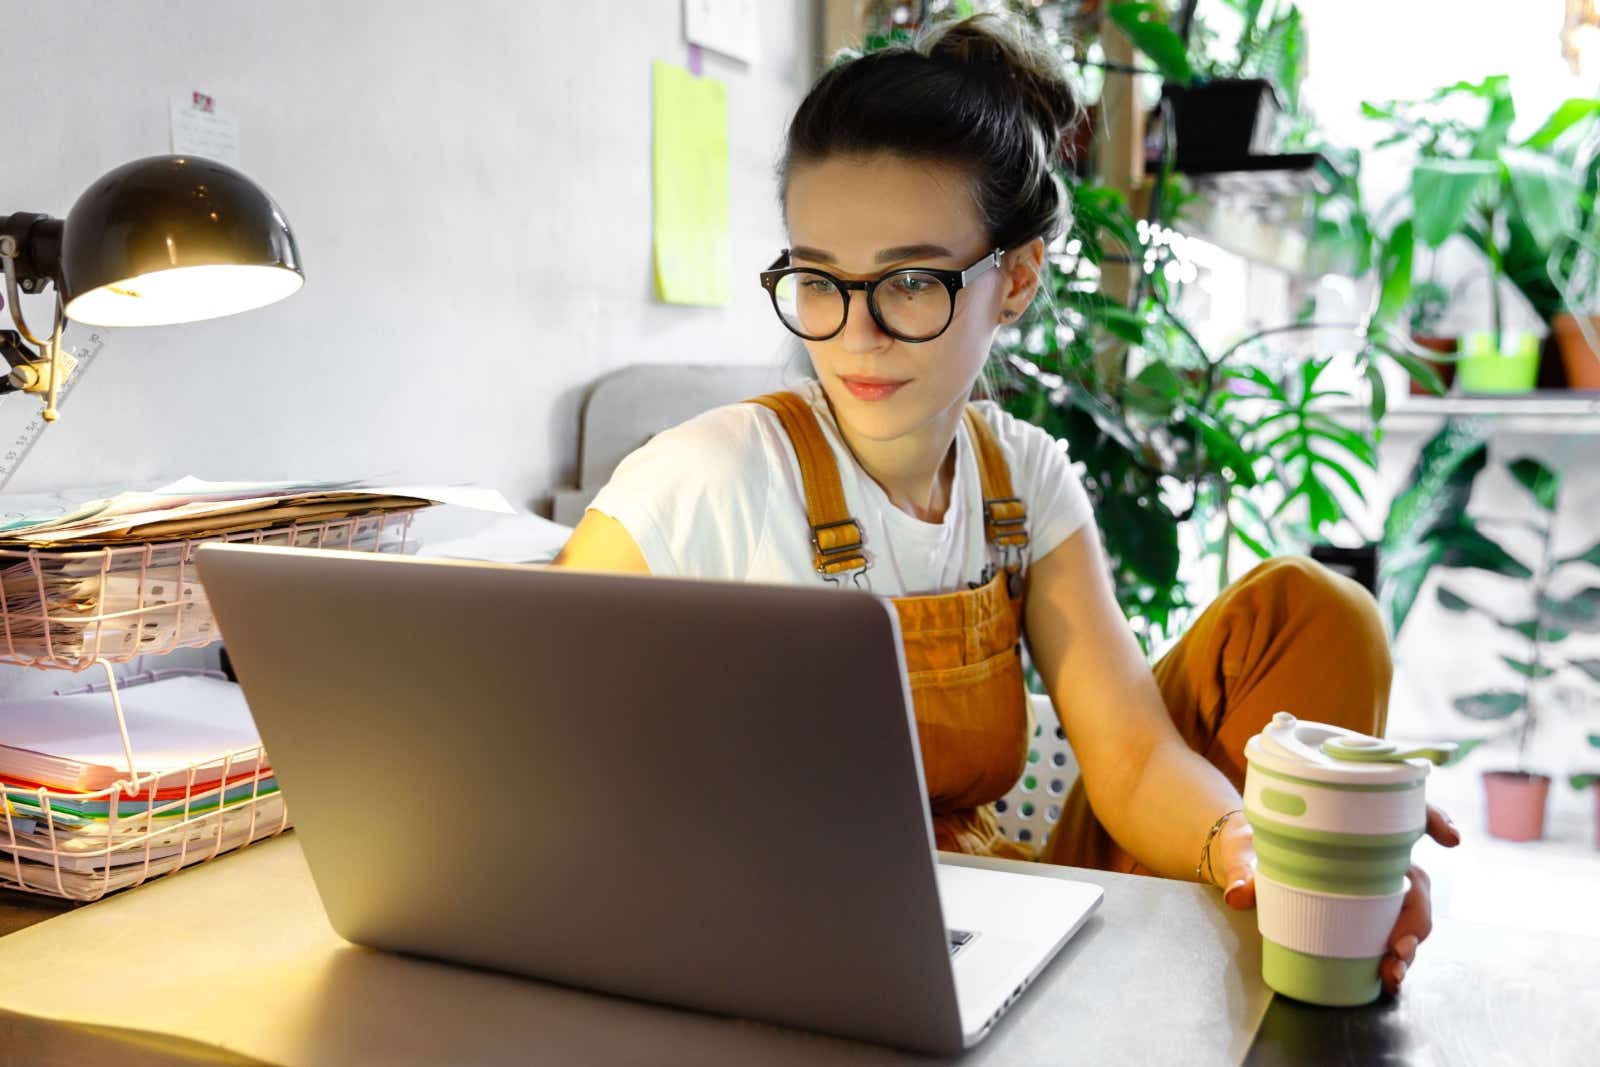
[0,677,288,899]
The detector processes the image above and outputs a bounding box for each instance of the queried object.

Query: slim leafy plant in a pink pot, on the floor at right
[1438,456,1600,841]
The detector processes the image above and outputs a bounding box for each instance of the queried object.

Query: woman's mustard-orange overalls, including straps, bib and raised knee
[755,394,1392,873]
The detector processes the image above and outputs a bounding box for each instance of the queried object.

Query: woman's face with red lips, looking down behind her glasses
[784,154,1010,442]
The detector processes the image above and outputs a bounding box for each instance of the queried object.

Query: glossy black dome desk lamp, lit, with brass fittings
[0,155,306,422]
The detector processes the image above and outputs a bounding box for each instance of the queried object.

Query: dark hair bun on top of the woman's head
[917,14,1082,144]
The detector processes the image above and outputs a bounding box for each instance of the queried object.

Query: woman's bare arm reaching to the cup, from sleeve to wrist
[1027,523,1243,885]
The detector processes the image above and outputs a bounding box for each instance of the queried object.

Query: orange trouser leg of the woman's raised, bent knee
[1038,557,1394,873]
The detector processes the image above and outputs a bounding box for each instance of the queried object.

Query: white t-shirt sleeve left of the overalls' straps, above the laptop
[589,405,771,581]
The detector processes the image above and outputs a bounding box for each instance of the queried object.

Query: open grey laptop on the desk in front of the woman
[197,545,1101,1054]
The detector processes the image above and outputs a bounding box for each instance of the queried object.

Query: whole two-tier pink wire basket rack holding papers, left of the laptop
[0,507,421,901]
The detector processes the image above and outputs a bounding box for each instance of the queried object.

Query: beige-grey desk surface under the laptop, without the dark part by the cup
[0,835,1270,1067]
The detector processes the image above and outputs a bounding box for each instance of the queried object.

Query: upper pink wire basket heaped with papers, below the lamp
[0,509,419,670]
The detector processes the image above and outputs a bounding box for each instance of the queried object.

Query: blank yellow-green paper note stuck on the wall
[654,59,733,304]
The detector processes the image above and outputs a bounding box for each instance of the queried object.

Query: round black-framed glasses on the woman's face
[762,248,1003,342]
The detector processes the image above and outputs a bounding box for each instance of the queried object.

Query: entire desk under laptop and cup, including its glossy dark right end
[0,833,1600,1067]
